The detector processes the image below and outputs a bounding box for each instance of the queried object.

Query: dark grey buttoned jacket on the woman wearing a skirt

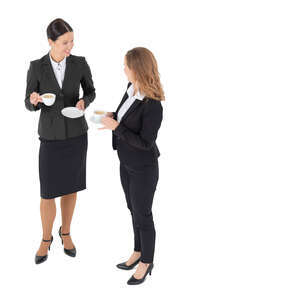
[25,53,96,140]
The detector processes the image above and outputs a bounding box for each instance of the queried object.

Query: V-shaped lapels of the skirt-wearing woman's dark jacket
[42,53,74,92]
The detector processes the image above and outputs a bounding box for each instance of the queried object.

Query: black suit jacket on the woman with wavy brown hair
[113,83,163,165]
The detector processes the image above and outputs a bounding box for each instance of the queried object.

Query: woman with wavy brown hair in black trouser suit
[101,47,164,285]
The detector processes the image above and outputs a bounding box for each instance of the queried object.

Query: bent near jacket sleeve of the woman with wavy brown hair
[113,100,163,150]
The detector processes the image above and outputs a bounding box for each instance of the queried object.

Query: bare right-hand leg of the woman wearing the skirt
[60,193,77,249]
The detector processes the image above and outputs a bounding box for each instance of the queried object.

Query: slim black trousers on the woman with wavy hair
[120,163,158,263]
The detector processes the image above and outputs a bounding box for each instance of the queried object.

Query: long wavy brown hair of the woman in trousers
[125,47,165,101]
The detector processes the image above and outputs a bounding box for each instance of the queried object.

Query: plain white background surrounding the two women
[0,0,300,300]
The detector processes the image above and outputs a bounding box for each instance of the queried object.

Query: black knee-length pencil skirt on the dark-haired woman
[39,133,88,199]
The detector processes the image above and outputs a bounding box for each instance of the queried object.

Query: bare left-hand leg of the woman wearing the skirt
[37,198,56,256]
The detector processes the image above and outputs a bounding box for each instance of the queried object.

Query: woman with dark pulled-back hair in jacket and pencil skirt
[25,19,95,264]
